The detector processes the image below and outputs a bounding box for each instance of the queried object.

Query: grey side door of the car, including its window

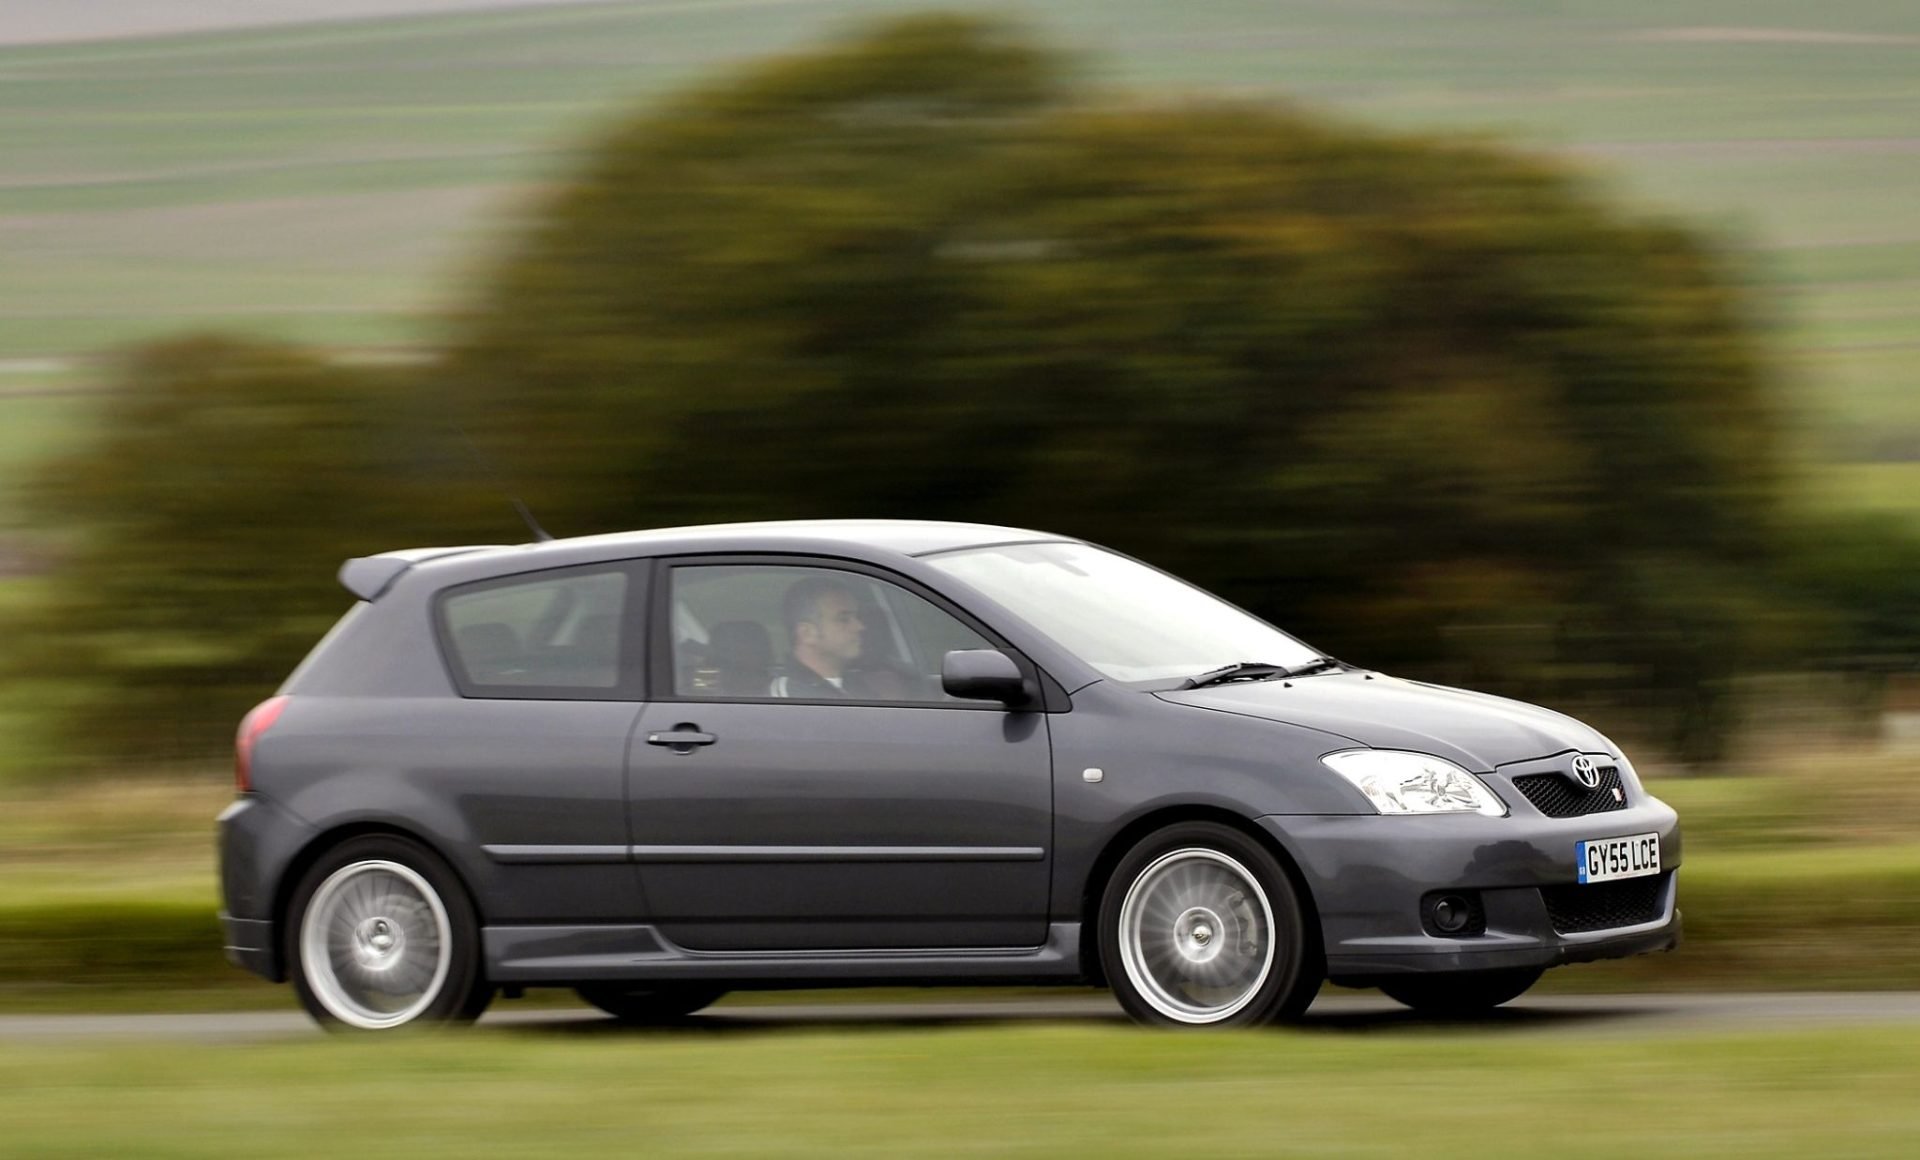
[628,557,1052,951]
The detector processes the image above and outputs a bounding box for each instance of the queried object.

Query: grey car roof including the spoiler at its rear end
[340,519,1071,599]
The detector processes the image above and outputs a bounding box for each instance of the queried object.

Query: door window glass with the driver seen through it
[672,565,993,705]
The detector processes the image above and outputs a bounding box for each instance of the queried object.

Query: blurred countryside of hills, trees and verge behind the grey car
[0,0,1920,1129]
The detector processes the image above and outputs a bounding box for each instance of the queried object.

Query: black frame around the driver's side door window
[647,551,1071,713]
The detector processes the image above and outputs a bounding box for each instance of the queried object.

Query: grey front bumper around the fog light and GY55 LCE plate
[1260,787,1680,985]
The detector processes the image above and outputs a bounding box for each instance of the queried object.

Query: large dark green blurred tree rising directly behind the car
[445,17,1786,757]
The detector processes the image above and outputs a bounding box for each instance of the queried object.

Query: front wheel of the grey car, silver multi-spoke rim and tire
[1098,822,1321,1027]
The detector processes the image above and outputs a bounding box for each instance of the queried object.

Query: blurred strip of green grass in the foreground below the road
[0,1026,1920,1158]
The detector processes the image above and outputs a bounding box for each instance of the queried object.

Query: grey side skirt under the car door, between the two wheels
[480,922,1081,987]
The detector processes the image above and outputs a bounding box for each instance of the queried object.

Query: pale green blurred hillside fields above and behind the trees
[0,0,1920,491]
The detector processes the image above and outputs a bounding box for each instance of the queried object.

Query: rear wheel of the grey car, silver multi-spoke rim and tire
[284,834,493,1031]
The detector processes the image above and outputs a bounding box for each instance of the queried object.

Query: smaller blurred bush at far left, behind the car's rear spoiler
[6,338,499,761]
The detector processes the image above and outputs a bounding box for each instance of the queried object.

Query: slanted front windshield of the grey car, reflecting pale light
[927,544,1317,684]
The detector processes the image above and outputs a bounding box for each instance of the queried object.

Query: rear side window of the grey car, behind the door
[440,570,628,695]
